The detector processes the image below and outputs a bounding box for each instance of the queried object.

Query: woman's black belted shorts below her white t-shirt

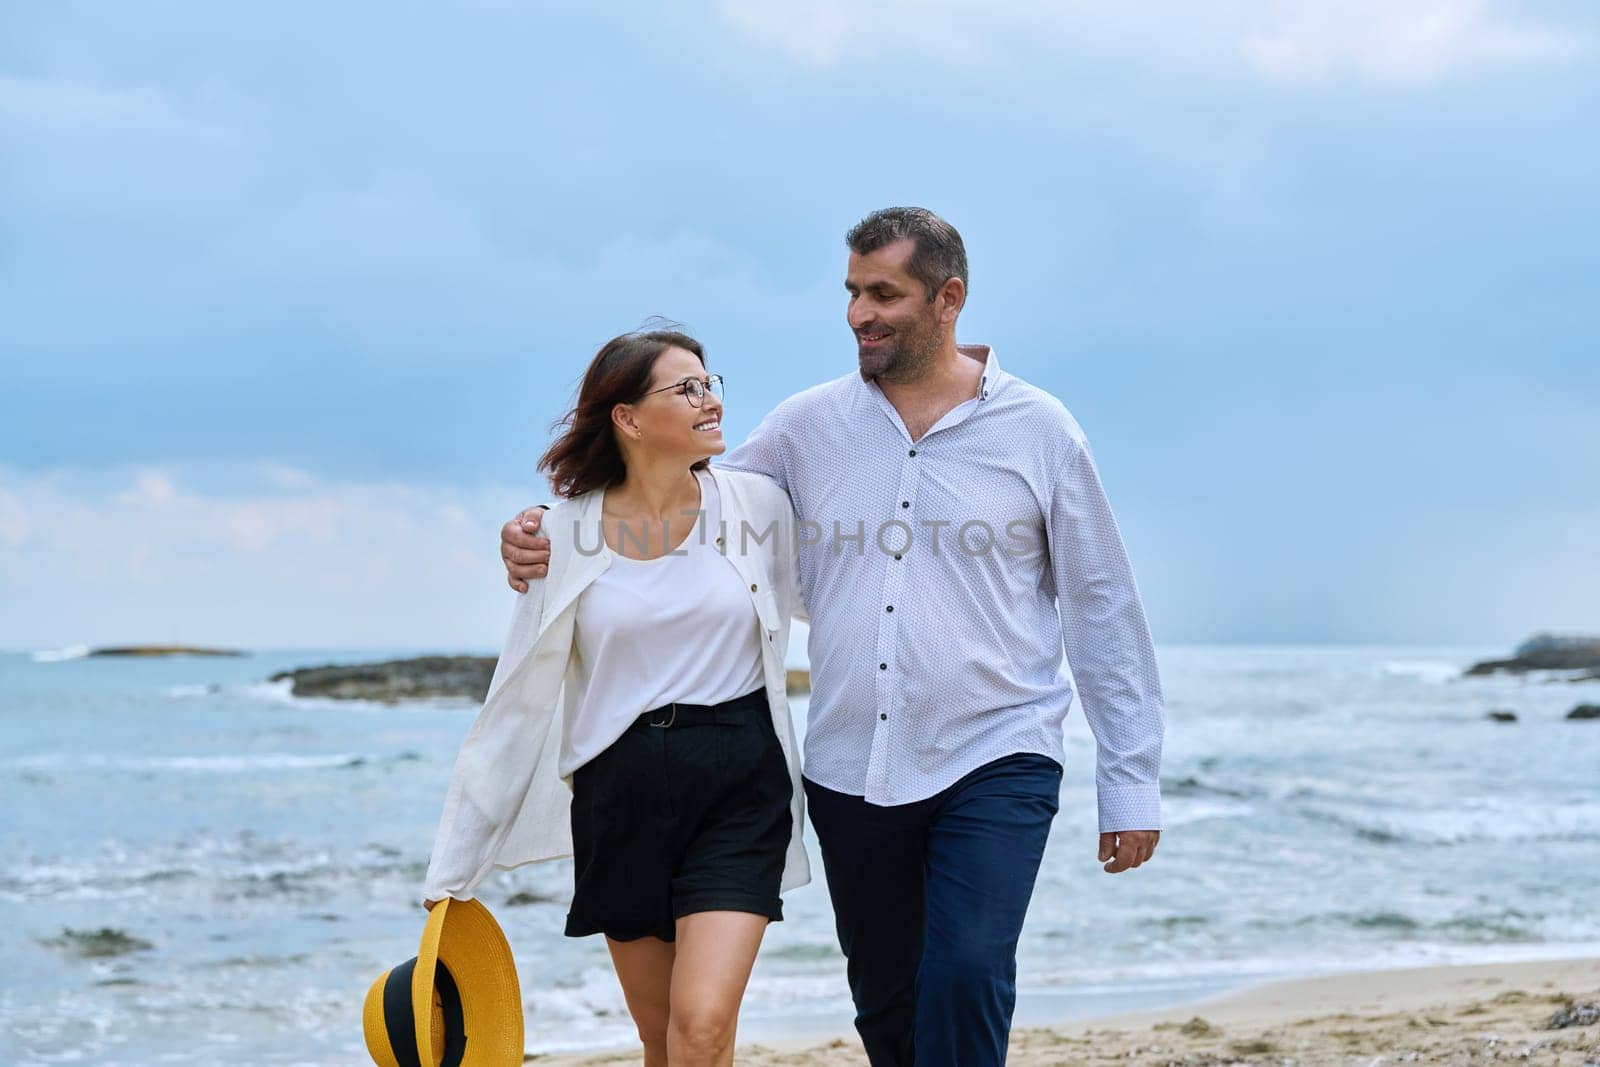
[566,688,794,941]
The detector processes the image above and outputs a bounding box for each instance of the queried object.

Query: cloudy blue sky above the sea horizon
[0,0,1600,648]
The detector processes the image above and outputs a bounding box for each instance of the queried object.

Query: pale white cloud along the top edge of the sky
[722,0,1589,85]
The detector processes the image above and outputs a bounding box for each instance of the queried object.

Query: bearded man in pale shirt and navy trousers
[501,208,1165,1067]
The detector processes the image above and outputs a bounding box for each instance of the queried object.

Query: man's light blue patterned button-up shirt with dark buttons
[718,346,1165,832]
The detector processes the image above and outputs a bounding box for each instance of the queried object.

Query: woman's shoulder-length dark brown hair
[539,330,709,498]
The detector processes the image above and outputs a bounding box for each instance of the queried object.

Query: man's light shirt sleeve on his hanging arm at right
[1048,440,1165,833]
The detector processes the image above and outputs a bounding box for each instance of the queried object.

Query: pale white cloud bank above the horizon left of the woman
[0,464,539,649]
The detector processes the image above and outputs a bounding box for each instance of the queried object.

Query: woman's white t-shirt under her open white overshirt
[560,470,765,776]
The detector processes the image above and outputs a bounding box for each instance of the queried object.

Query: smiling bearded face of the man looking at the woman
[845,238,941,381]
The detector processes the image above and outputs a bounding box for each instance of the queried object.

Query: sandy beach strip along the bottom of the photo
[528,958,1600,1067]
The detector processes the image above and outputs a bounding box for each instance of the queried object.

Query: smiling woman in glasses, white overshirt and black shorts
[424,330,810,1067]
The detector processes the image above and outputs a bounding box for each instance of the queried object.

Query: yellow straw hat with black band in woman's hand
[362,897,522,1067]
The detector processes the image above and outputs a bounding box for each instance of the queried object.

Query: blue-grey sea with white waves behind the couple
[0,646,1600,1064]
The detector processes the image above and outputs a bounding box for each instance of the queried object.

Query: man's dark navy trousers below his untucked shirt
[805,753,1061,1067]
